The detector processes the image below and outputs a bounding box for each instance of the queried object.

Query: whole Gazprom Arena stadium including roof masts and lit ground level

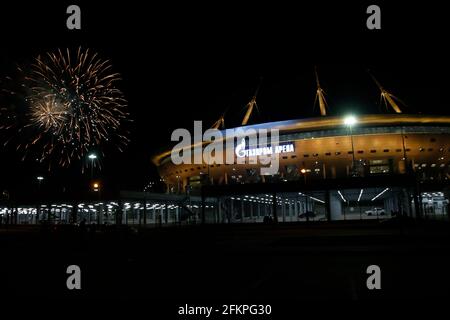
[152,73,450,222]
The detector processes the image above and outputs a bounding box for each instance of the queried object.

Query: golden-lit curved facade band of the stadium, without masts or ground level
[153,115,450,193]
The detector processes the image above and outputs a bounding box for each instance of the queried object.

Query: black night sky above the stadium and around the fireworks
[0,1,449,199]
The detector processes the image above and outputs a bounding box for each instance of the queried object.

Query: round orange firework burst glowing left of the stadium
[2,48,128,167]
